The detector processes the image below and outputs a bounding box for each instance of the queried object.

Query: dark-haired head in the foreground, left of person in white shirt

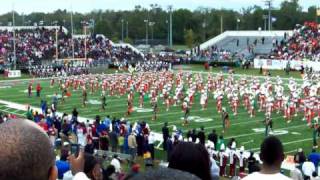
[168,142,211,180]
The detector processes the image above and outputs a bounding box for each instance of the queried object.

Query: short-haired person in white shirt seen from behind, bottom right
[243,136,290,180]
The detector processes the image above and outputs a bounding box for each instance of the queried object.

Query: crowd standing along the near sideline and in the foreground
[0,105,320,180]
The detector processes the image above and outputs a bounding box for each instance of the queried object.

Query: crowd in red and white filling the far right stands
[271,22,320,61]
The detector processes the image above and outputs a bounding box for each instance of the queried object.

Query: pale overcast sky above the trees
[0,0,320,14]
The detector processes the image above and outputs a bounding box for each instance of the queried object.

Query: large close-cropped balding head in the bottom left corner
[0,119,58,180]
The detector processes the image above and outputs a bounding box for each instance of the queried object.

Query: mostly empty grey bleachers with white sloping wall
[200,31,292,54]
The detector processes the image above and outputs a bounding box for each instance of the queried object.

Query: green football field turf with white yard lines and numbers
[0,66,312,157]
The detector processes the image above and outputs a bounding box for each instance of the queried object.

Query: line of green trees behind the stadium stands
[0,0,317,45]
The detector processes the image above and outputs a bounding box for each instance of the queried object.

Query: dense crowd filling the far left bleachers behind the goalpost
[0,28,142,68]
